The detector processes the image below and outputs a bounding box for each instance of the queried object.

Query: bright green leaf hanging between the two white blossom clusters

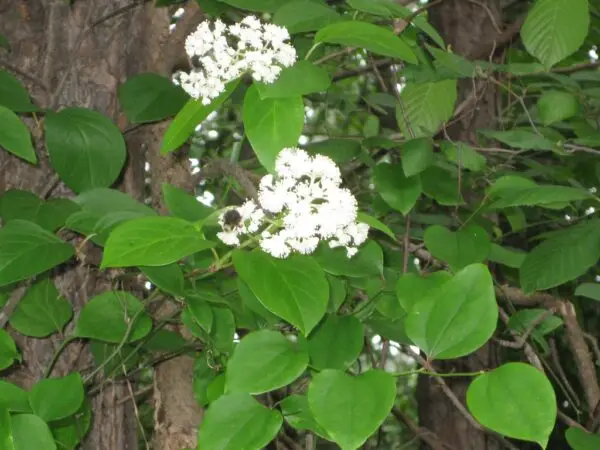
[243,85,304,171]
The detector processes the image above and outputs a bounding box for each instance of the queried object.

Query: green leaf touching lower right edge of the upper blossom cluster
[256,60,331,99]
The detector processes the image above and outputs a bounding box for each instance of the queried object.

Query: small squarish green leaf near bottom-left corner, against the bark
[29,372,84,422]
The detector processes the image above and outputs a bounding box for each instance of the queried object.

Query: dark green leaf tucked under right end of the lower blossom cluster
[314,240,383,278]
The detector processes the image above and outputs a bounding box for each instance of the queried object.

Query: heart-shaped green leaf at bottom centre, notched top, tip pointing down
[308,369,396,450]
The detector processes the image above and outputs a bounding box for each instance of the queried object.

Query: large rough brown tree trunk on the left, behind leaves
[0,0,201,450]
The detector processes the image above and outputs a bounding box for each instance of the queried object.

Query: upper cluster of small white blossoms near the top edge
[173,16,296,105]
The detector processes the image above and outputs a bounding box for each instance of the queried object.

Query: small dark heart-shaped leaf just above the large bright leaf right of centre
[424,225,491,272]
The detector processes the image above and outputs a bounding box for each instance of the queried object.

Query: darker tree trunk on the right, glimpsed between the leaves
[417,0,502,450]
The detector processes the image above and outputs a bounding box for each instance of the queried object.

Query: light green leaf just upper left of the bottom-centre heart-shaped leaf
[225,330,308,395]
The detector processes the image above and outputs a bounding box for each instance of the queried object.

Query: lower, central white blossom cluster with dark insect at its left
[217,148,369,258]
